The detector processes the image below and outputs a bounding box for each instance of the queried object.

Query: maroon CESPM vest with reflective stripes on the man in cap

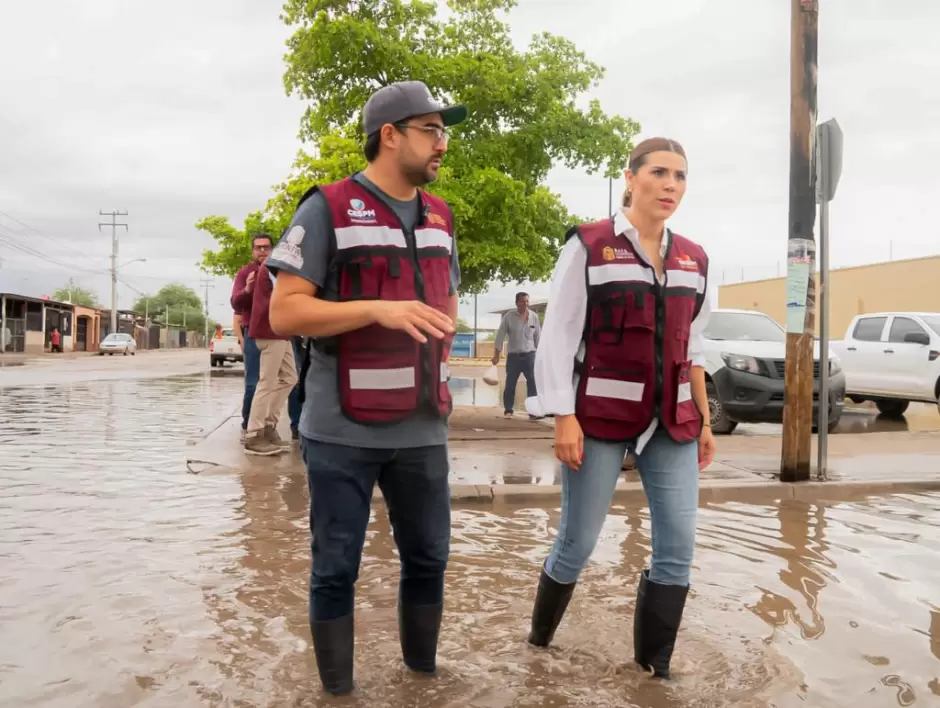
[301,178,454,425]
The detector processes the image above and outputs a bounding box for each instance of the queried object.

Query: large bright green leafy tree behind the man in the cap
[197,0,639,293]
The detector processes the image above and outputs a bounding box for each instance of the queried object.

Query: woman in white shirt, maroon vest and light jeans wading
[527,138,715,678]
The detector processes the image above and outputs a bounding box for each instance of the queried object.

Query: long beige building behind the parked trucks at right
[718,256,940,339]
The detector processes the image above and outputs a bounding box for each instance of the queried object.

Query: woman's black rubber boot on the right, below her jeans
[633,570,689,679]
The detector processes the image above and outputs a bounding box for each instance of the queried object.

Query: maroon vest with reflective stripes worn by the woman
[569,219,708,442]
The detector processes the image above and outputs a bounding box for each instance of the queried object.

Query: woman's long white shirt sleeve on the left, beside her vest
[526,238,587,415]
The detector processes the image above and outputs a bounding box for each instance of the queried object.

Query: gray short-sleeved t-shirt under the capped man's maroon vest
[267,173,460,448]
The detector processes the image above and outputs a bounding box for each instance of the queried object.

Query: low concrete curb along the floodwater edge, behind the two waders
[372,478,940,506]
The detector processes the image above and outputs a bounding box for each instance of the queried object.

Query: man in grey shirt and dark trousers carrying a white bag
[493,293,542,420]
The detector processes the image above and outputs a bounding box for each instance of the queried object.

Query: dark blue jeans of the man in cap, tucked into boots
[302,438,450,622]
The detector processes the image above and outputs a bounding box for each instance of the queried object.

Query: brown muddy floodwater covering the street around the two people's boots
[0,374,940,708]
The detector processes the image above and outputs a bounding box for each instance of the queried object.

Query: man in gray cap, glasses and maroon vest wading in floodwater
[267,81,467,695]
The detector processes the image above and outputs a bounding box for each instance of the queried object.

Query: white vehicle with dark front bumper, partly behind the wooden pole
[705,309,845,434]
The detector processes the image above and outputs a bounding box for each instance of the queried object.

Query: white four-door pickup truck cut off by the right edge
[831,312,940,417]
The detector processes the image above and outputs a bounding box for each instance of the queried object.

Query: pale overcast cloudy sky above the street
[0,0,940,326]
